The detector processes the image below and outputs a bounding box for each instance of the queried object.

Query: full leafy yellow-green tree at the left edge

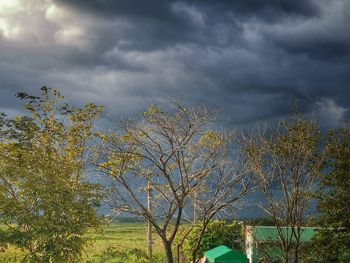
[0,87,102,262]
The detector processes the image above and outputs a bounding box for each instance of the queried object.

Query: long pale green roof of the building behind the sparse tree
[253,226,317,242]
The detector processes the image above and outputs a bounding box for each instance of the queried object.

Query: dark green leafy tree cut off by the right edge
[307,128,350,263]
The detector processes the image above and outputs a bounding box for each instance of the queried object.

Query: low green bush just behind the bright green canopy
[184,220,243,258]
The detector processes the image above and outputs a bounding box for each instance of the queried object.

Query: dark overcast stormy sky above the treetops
[0,0,350,126]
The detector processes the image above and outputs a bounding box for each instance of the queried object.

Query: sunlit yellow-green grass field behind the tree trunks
[0,225,167,263]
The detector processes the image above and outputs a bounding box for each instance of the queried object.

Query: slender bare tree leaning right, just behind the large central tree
[185,146,250,262]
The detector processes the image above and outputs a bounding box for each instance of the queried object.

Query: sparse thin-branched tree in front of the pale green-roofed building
[242,114,322,263]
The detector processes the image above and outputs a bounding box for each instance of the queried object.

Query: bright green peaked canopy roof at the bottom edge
[204,245,248,263]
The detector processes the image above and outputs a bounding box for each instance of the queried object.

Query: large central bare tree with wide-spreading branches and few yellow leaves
[98,101,249,263]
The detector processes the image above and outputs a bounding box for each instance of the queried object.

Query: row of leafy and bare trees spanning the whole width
[0,87,350,263]
